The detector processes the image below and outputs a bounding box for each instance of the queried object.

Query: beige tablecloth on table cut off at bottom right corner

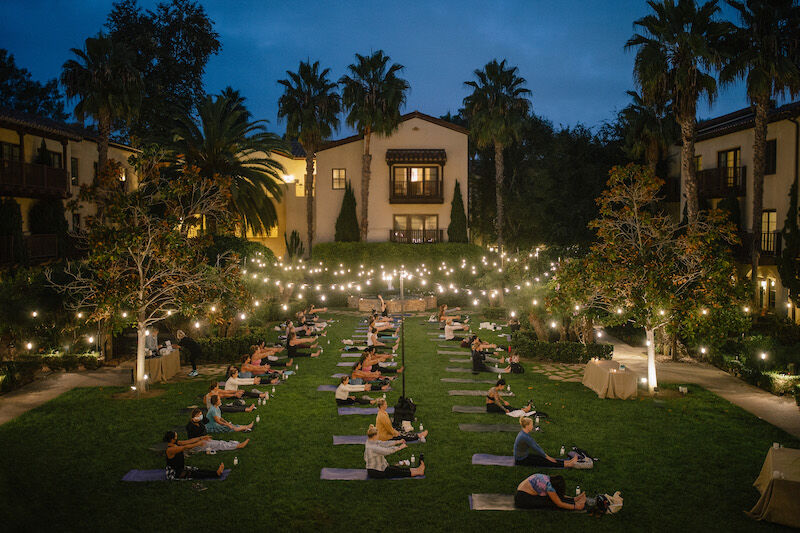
[747,448,800,527]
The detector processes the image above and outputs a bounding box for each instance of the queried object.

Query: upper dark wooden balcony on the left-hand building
[0,159,69,198]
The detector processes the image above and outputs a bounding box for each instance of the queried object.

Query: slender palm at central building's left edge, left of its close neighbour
[278,61,341,256]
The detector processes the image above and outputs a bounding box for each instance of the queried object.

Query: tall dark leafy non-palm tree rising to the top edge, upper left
[105,0,221,142]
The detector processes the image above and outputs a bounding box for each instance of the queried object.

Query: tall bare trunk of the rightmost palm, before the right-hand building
[750,96,769,308]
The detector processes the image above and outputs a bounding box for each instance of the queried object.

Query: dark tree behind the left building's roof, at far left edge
[0,48,68,121]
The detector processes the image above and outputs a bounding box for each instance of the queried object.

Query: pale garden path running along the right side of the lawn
[608,336,800,437]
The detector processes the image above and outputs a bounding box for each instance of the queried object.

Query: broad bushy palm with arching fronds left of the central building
[169,88,287,234]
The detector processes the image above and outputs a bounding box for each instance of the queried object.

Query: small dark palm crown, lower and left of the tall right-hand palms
[620,91,678,173]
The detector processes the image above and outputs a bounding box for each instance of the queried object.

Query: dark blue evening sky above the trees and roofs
[0,0,772,135]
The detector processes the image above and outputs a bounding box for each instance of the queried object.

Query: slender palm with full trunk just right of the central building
[464,59,531,247]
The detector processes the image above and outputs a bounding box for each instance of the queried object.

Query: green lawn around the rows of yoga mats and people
[0,315,800,531]
